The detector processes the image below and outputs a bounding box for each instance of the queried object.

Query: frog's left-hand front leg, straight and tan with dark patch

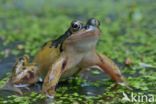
[42,57,67,96]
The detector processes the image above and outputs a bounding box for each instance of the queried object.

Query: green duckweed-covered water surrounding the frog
[0,0,156,104]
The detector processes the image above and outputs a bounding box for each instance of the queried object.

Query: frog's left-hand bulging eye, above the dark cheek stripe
[71,21,82,32]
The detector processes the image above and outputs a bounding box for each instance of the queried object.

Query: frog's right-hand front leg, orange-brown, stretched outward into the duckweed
[83,52,125,84]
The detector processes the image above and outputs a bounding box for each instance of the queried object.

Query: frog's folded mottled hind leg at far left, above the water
[10,56,38,87]
